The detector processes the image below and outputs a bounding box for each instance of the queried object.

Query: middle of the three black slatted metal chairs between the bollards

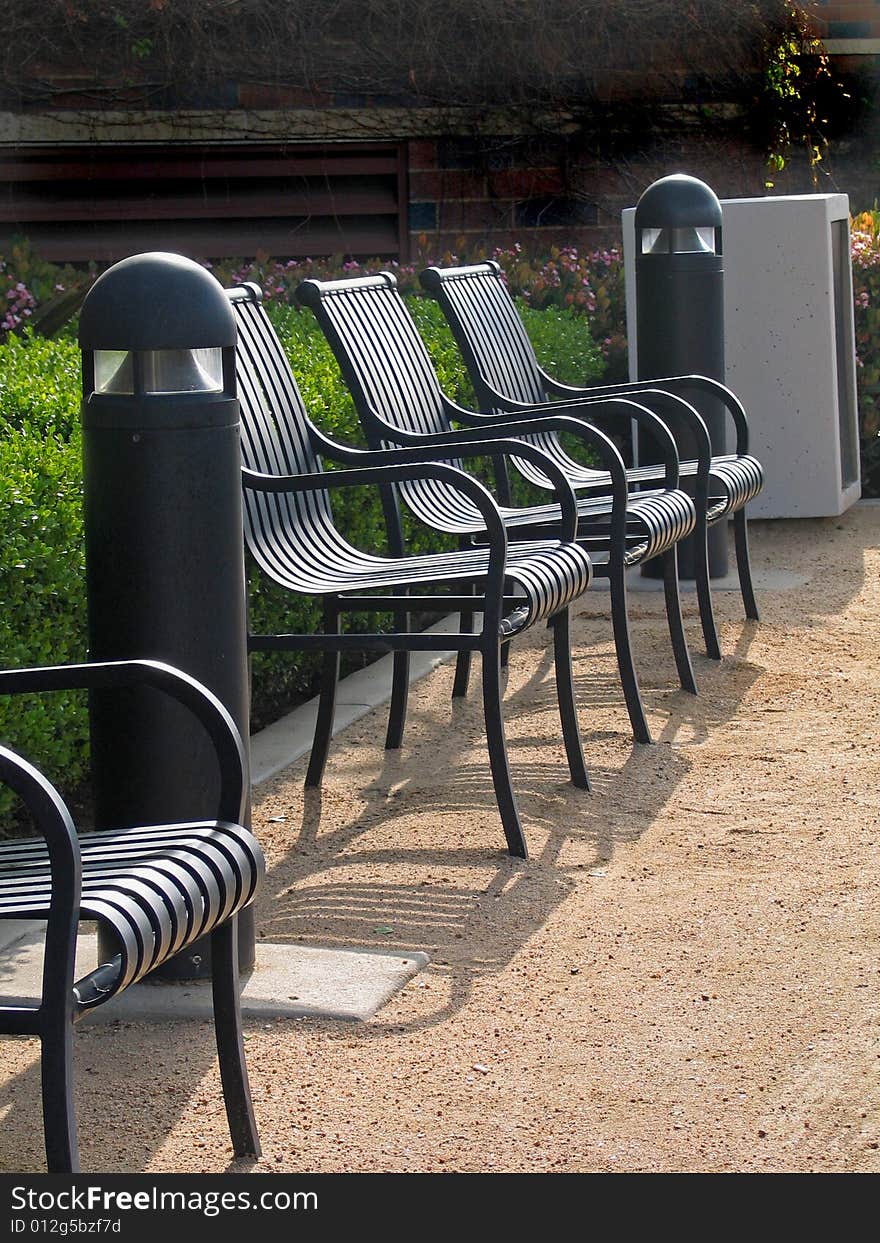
[297,272,696,742]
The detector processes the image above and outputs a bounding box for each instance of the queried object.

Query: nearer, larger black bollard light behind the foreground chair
[80,254,255,979]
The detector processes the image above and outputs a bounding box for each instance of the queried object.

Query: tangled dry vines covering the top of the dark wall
[0,0,850,188]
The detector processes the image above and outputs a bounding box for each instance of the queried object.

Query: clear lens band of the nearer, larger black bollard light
[94,349,222,394]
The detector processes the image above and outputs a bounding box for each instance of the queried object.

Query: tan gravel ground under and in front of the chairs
[0,505,880,1172]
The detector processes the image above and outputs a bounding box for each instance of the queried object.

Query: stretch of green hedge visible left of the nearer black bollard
[0,332,88,809]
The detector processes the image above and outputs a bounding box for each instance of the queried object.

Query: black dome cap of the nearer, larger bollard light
[80,251,236,349]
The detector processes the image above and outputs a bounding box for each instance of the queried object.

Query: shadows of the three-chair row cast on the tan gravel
[249,606,761,1039]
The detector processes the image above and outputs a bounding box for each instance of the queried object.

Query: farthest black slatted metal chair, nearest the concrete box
[419,260,763,659]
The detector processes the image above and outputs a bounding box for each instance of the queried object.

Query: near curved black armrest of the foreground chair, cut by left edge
[0,747,82,1032]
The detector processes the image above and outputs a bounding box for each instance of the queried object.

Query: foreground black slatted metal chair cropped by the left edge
[0,660,265,1172]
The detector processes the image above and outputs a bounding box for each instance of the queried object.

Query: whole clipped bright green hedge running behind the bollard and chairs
[0,296,603,807]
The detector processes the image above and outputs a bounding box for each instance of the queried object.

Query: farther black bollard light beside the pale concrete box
[635,173,727,578]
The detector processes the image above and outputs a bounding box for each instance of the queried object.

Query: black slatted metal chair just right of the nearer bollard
[227,285,592,858]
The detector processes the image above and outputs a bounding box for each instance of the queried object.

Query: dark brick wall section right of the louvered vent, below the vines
[409,0,880,254]
